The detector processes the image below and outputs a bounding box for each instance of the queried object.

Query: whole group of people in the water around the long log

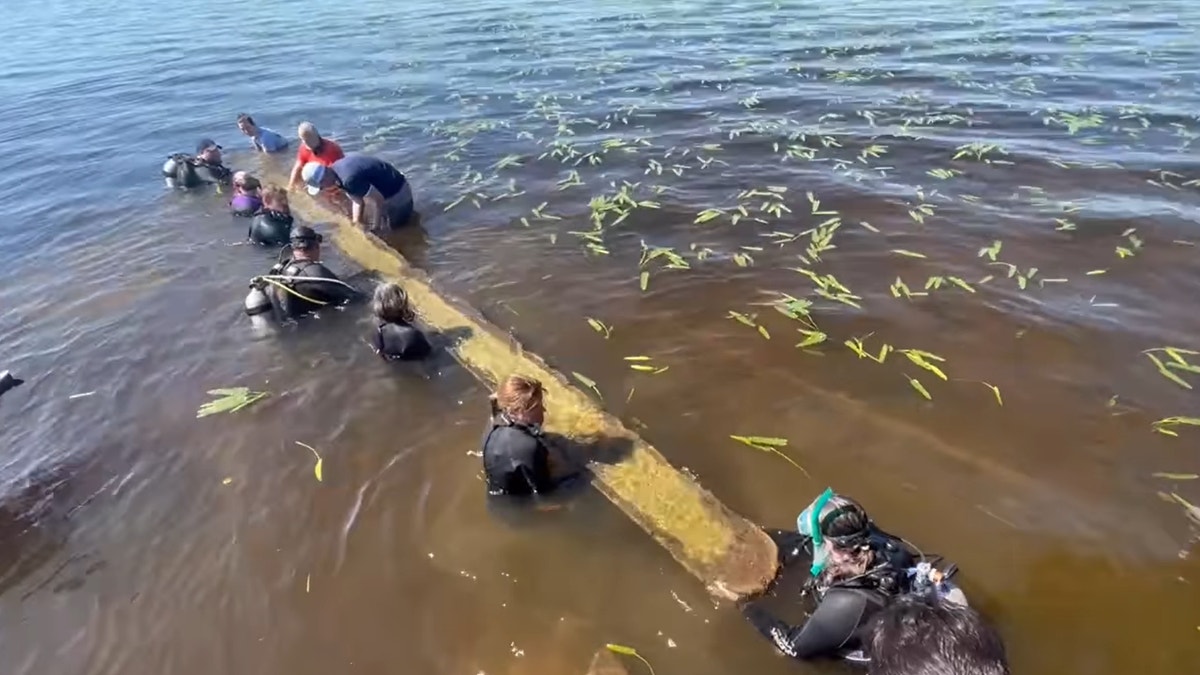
[163,114,1008,675]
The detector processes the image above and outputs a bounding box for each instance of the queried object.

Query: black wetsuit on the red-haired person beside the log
[484,413,554,495]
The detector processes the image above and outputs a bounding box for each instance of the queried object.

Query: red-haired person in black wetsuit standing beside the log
[484,375,554,496]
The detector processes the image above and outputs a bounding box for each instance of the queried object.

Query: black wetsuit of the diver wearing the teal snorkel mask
[742,531,913,659]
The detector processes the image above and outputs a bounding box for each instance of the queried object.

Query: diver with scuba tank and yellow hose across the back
[245,225,358,319]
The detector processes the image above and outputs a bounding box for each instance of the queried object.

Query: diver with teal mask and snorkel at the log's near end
[720,490,965,663]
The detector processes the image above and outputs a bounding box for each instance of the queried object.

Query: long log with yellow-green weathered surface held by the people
[265,176,778,596]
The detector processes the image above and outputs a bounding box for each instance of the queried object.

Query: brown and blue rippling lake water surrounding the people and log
[0,0,1200,675]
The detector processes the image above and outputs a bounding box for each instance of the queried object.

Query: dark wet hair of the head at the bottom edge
[866,596,1008,675]
